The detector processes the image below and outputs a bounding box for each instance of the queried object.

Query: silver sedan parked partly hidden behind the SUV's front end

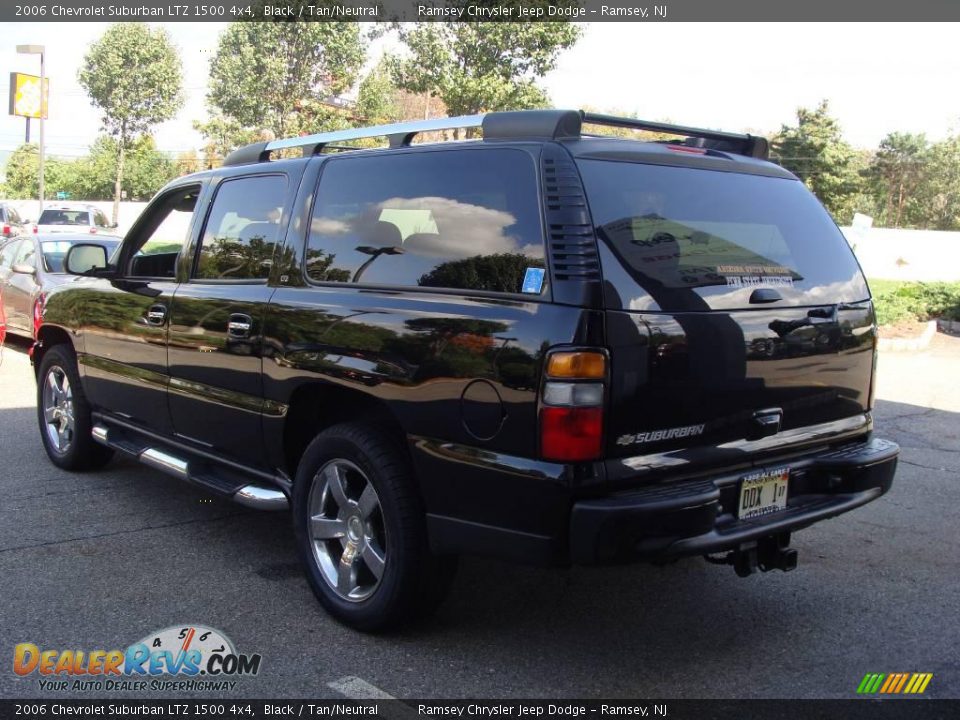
[0,233,120,337]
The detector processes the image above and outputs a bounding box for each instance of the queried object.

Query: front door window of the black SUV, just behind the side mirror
[125,185,200,278]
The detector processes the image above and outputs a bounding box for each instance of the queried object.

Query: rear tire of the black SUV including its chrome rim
[293,423,456,632]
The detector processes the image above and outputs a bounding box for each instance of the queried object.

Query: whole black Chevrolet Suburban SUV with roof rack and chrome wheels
[33,111,898,630]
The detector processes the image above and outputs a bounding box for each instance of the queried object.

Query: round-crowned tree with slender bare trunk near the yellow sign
[79,23,183,222]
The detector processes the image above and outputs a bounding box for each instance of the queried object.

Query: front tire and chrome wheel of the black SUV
[37,345,113,470]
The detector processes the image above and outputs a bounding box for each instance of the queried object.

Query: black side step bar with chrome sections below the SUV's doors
[90,424,288,510]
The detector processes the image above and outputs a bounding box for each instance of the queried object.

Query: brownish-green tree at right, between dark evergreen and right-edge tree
[864,132,930,227]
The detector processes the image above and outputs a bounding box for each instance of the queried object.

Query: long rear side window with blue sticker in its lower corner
[305,148,546,294]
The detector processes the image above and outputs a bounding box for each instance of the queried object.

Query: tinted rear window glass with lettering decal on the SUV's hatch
[580,160,869,312]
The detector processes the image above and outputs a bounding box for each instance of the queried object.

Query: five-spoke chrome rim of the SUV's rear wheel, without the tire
[307,459,387,602]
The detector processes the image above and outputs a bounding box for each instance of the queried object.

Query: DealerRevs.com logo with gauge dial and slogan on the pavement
[13,625,261,692]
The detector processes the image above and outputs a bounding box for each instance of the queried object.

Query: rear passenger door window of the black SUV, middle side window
[194,175,287,280]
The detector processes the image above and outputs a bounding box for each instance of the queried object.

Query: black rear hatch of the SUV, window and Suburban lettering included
[578,158,875,459]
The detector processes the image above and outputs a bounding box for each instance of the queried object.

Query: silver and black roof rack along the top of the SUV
[223,110,768,165]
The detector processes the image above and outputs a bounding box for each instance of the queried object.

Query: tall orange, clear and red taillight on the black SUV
[540,350,607,462]
